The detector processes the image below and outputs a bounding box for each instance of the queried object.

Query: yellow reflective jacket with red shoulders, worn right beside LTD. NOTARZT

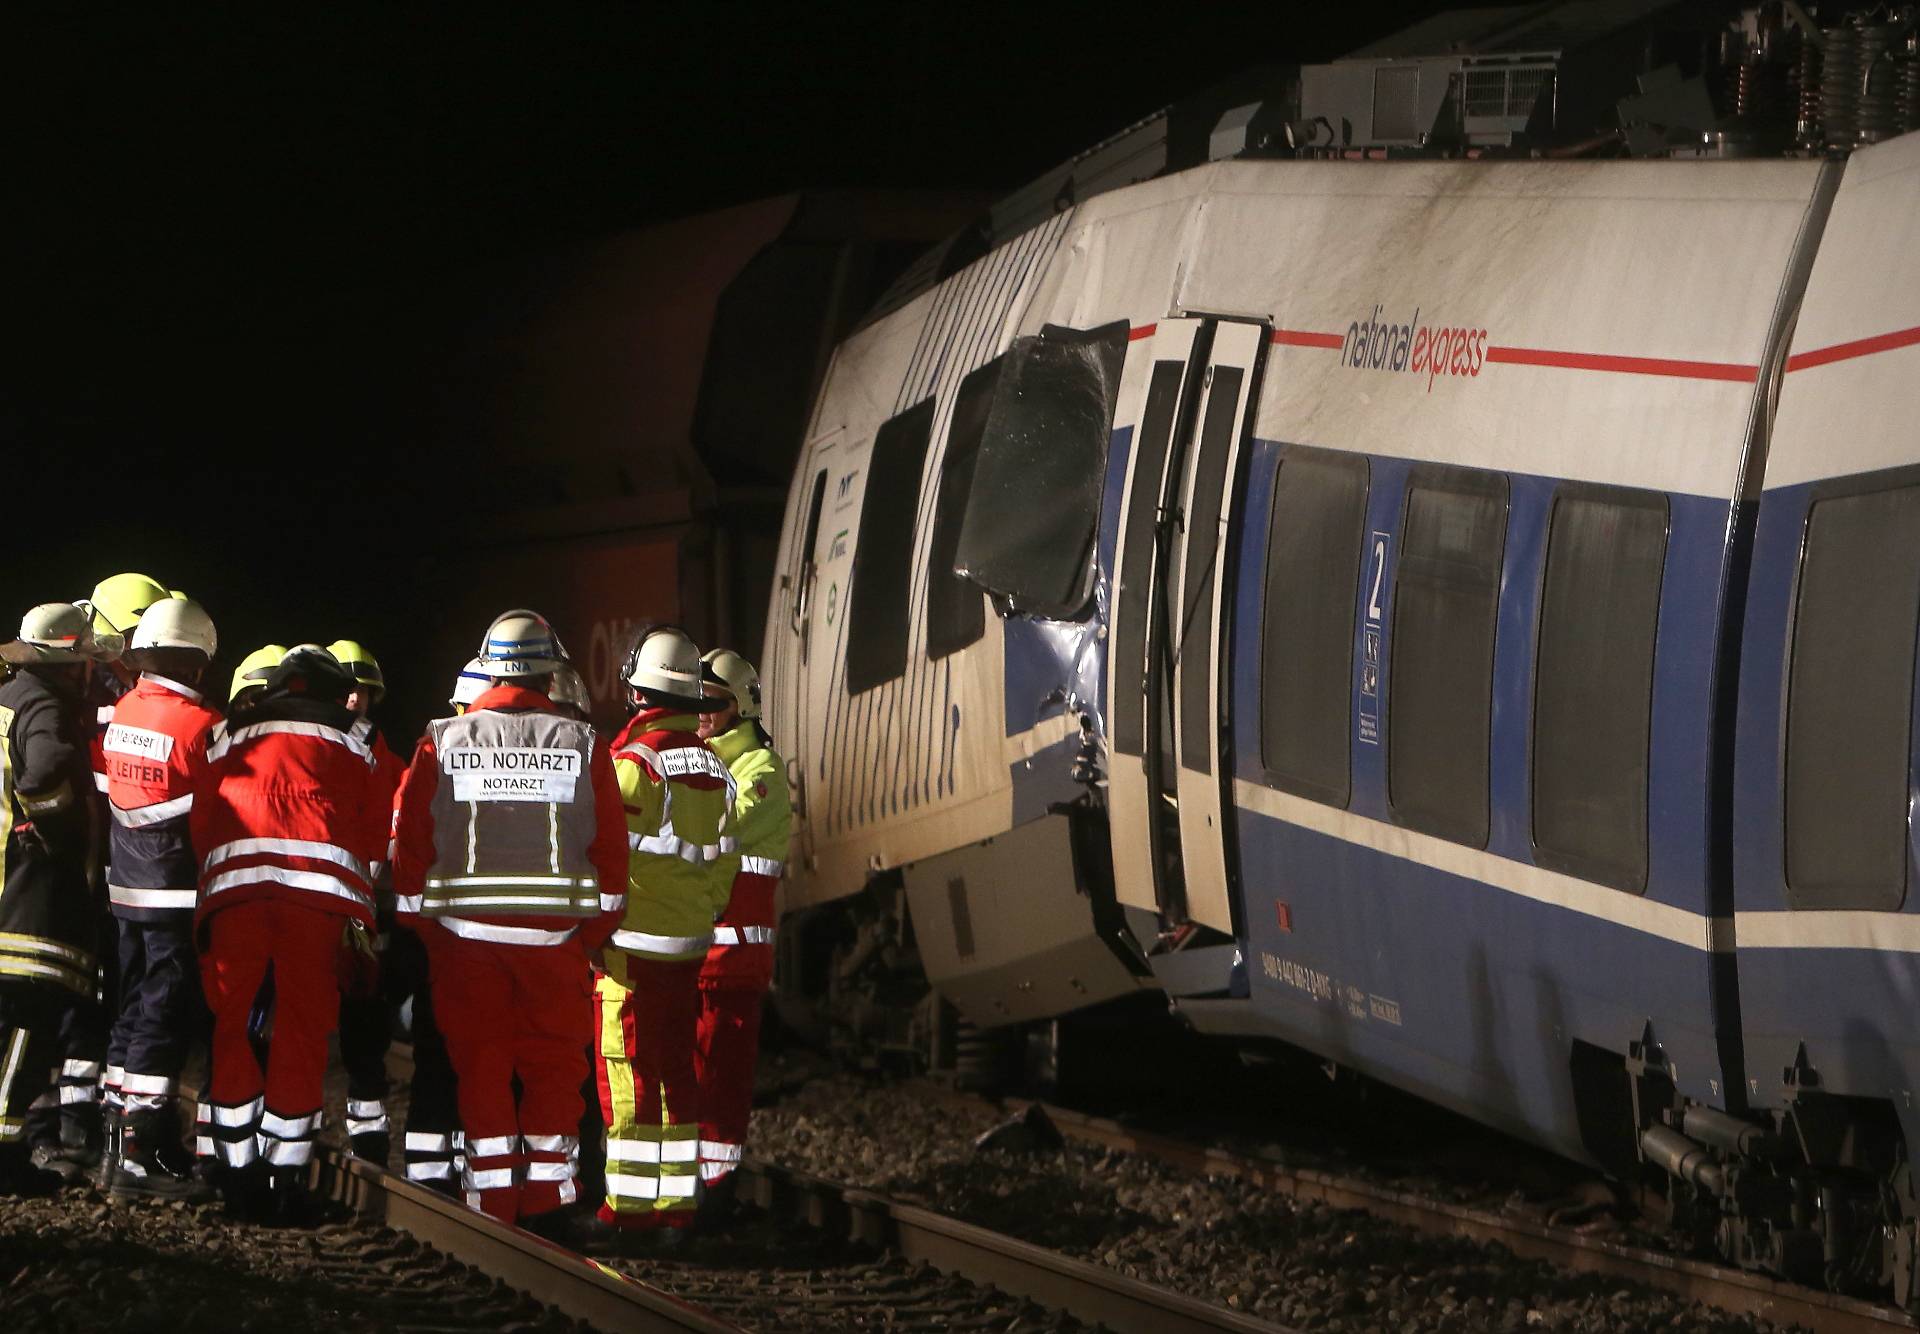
[612,708,733,960]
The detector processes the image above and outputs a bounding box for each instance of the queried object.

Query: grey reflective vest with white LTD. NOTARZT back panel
[414,708,601,917]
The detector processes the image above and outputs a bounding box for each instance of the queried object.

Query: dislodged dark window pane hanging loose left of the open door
[954,321,1127,618]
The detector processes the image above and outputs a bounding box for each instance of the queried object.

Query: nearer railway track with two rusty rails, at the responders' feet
[313,1050,1267,1334]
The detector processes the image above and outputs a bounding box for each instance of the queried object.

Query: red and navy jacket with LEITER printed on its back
[100,672,221,921]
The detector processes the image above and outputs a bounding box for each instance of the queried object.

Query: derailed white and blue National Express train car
[764,28,1920,1301]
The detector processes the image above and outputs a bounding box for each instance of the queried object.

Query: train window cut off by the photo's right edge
[1786,486,1920,910]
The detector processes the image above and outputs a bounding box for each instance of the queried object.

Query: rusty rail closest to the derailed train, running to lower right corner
[948,1084,1920,1334]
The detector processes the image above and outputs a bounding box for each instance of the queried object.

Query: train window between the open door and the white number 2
[1260,445,1367,806]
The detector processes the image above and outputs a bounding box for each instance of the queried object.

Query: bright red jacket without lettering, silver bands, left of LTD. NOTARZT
[192,697,386,927]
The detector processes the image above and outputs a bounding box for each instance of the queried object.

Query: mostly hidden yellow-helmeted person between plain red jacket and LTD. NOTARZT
[326,639,407,1167]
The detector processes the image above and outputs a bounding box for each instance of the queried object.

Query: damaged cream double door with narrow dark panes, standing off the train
[1108,319,1267,935]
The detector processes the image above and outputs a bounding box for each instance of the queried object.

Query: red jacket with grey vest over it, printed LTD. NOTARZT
[394,685,626,954]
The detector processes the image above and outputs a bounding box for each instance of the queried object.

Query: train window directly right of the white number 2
[1386,466,1507,846]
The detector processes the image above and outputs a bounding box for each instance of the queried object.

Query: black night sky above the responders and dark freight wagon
[0,0,1446,721]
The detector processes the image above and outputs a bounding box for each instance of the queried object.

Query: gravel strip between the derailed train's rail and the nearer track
[751,1077,1786,1334]
